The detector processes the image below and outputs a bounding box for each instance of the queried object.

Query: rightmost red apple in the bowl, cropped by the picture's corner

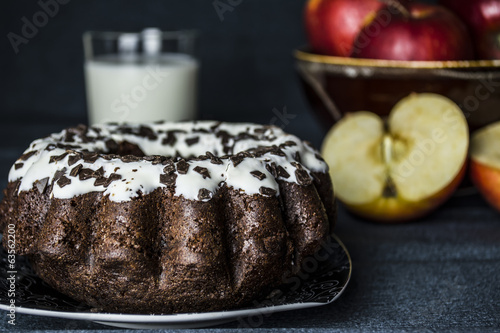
[440,0,500,59]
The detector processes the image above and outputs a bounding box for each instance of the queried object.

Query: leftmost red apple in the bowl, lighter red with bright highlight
[304,0,384,57]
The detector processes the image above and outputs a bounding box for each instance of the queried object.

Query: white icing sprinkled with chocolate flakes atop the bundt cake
[9,121,328,202]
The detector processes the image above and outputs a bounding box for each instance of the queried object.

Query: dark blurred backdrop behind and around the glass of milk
[0,0,319,141]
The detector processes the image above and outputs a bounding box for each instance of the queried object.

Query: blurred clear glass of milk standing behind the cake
[83,28,199,125]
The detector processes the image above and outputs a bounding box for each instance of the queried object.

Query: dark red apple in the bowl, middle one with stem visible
[352,0,474,61]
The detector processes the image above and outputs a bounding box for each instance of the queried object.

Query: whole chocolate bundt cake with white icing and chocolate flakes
[0,121,335,313]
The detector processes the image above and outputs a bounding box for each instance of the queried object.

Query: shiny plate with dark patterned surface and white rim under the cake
[0,235,352,328]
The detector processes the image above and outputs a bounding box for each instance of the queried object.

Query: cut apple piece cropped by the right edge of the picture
[470,122,500,211]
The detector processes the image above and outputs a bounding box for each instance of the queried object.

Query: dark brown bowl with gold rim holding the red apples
[294,48,500,130]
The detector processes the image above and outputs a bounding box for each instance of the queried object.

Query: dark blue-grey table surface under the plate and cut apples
[0,115,500,332]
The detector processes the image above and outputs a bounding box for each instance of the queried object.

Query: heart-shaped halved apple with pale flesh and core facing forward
[322,93,469,222]
